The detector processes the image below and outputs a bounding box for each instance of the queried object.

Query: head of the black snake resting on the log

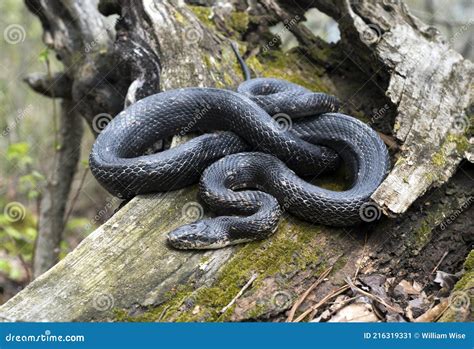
[168,220,228,250]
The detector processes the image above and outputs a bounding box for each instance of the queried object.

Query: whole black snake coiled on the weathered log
[90,46,389,249]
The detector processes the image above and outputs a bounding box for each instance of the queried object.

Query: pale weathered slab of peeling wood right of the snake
[282,0,474,214]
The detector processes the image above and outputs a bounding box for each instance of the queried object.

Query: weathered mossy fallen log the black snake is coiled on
[0,0,474,321]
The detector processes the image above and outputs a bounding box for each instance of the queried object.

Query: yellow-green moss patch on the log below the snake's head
[115,217,340,321]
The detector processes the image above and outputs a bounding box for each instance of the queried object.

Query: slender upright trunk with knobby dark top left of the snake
[25,0,121,278]
